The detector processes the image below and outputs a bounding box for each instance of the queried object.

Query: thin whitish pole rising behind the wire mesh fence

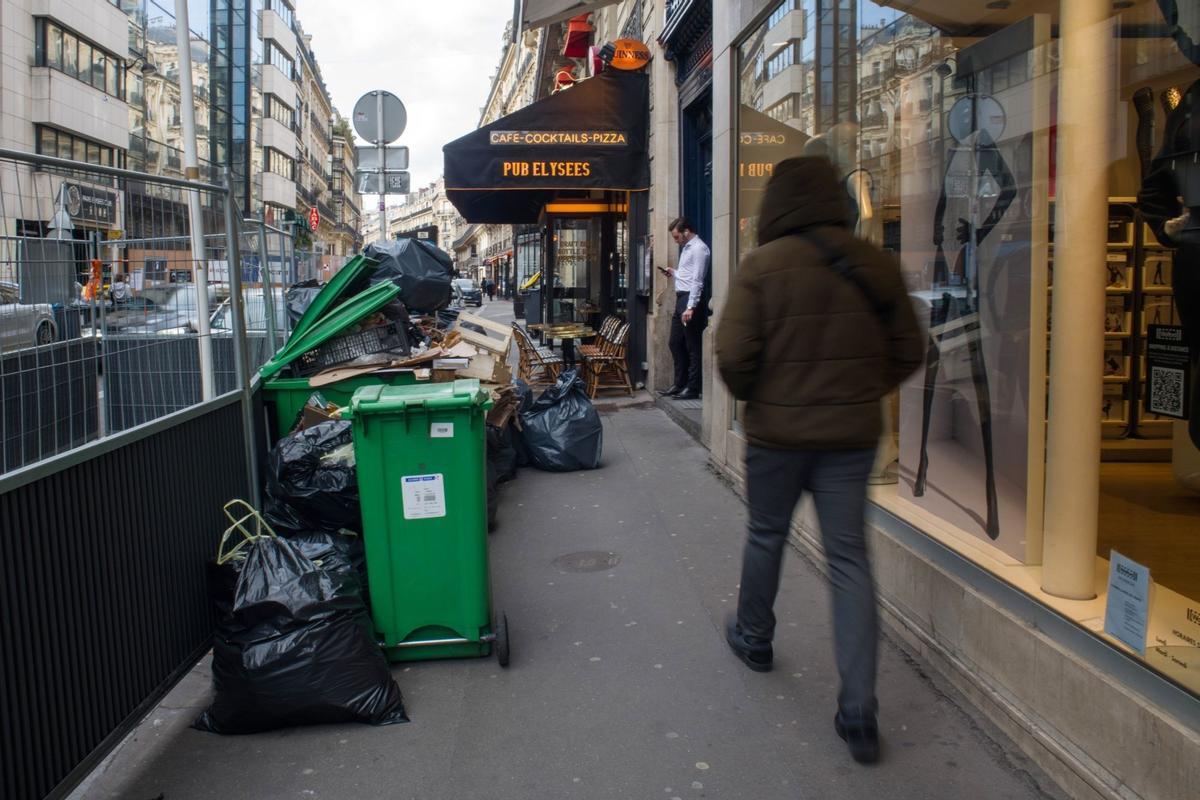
[175,0,214,399]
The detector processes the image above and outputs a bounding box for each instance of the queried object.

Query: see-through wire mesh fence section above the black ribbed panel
[0,151,278,476]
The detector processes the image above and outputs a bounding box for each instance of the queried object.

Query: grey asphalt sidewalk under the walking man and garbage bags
[76,407,1062,800]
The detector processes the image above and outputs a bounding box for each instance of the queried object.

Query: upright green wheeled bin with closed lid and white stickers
[343,380,508,666]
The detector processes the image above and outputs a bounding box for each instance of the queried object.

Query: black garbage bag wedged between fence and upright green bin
[263,420,362,536]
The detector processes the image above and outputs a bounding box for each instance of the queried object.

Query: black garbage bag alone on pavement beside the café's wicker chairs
[521,369,604,473]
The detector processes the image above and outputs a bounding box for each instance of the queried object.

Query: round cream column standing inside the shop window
[1033,0,1118,600]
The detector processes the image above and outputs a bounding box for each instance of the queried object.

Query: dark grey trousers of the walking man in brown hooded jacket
[738,445,878,712]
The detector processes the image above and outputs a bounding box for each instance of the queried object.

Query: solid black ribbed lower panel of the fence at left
[0,399,247,800]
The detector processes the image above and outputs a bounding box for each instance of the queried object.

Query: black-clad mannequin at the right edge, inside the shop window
[1138,0,1200,447]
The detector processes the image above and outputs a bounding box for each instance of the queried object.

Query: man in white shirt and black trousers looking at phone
[660,217,709,399]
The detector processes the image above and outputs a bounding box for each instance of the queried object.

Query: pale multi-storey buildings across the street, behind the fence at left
[0,0,361,266]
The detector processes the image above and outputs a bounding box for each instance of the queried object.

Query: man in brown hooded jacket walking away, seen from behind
[716,157,924,763]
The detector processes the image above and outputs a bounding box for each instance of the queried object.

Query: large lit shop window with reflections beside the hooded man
[731,0,1200,693]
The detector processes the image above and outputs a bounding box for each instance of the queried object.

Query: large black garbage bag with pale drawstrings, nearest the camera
[193,536,408,734]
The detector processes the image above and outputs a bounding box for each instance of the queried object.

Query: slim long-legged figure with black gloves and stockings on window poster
[912,95,1016,540]
